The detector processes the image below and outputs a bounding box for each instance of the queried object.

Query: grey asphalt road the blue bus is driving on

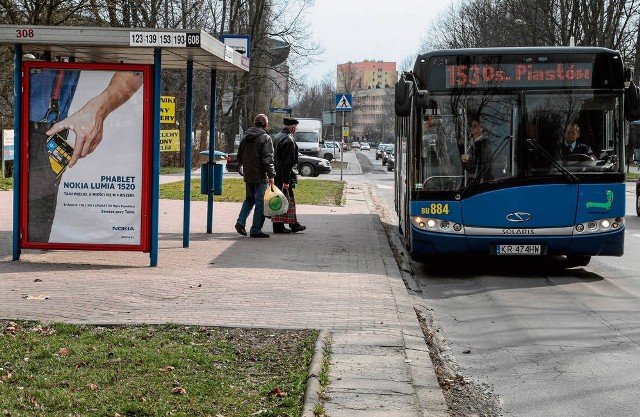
[348,148,640,417]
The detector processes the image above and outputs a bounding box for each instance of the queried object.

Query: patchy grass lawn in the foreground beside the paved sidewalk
[0,320,318,417]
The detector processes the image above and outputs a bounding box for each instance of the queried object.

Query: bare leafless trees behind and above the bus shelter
[0,0,318,160]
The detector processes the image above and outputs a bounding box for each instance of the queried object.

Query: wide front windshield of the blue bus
[412,89,622,191]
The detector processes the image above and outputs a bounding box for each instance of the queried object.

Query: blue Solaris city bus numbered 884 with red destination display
[394,47,640,267]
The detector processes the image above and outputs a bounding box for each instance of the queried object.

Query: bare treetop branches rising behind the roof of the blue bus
[420,0,640,63]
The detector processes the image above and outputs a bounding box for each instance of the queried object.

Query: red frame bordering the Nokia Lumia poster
[16,61,153,252]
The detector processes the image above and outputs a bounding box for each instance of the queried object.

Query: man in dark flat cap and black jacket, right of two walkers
[271,117,306,233]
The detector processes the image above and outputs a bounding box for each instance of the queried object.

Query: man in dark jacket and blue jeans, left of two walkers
[236,114,276,237]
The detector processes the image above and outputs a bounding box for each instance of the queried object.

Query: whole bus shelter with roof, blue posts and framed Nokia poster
[0,25,249,266]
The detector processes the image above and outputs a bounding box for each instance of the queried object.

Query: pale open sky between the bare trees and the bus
[305,0,454,82]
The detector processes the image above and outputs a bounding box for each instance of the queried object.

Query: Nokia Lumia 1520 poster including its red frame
[23,62,150,250]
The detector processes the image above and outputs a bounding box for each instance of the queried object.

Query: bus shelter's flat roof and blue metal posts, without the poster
[0,25,249,266]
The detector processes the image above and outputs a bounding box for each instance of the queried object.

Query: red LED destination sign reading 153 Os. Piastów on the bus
[445,63,593,88]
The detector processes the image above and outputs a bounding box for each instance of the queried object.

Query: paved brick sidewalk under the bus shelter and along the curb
[0,154,448,417]
